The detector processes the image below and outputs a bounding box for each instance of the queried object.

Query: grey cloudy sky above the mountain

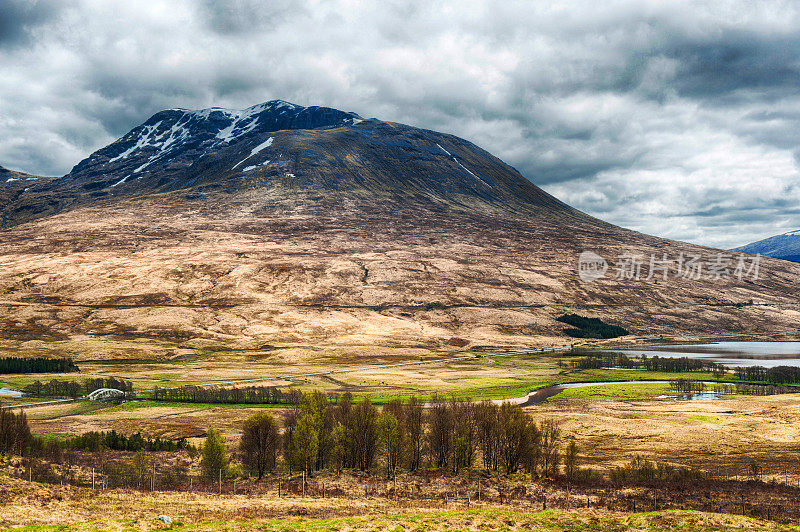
[0,0,800,247]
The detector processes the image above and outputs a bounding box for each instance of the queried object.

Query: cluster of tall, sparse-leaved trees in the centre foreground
[228,392,586,478]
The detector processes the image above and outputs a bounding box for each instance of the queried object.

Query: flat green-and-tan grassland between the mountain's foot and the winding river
[0,348,728,403]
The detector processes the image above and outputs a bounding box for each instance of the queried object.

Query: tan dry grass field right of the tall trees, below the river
[527,388,800,476]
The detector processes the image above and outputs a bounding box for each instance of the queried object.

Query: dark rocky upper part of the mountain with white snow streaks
[2,100,579,224]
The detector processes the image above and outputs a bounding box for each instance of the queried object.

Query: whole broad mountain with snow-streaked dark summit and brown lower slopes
[0,100,800,352]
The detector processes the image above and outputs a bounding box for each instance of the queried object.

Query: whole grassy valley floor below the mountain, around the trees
[0,338,800,531]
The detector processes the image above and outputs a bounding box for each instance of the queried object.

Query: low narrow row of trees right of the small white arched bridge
[151,386,302,405]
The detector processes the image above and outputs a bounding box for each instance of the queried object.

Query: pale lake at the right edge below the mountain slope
[611,342,800,368]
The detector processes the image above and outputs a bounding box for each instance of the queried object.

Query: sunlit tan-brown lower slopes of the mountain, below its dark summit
[0,191,800,359]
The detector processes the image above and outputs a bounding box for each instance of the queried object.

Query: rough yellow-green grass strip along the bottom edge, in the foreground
[0,476,798,532]
